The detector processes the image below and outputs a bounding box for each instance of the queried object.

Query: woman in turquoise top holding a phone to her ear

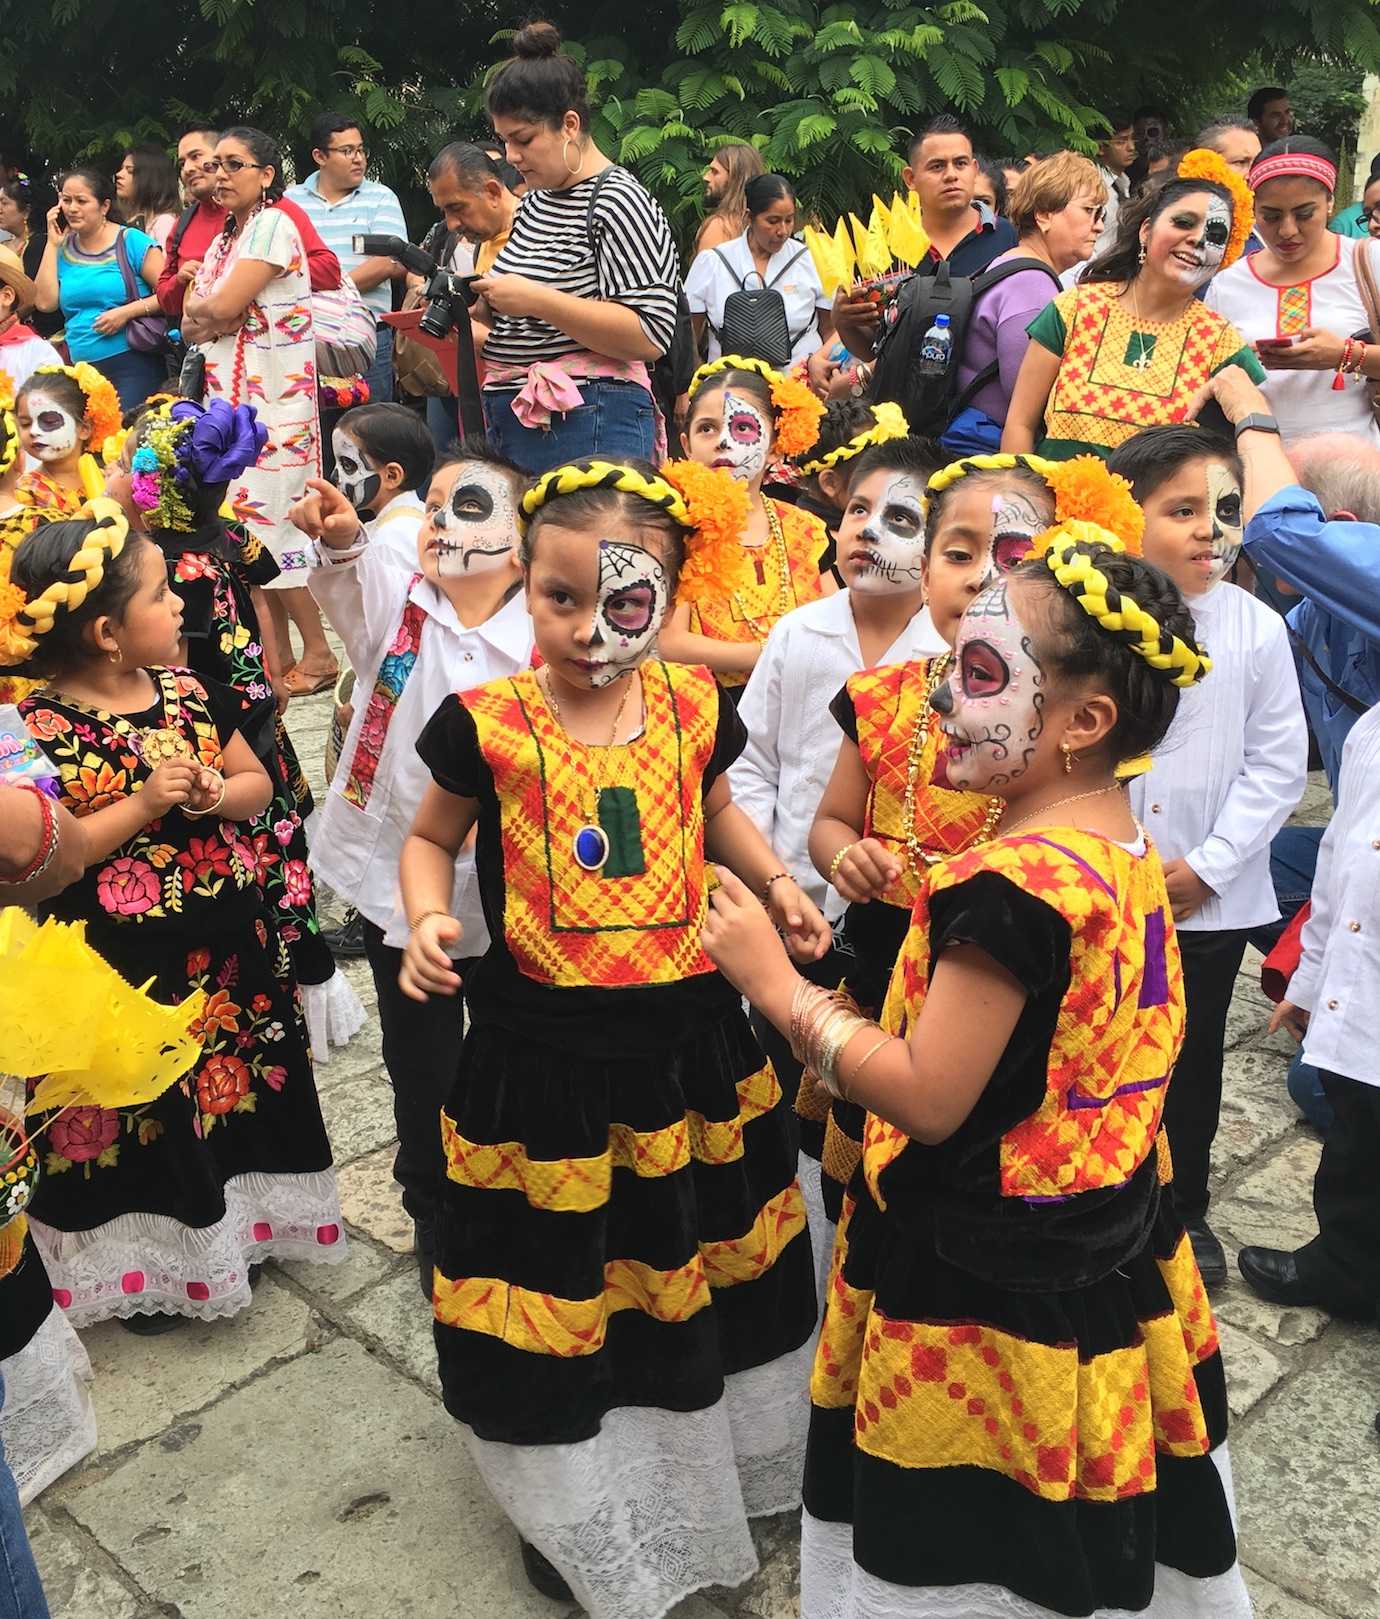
[34,168,167,410]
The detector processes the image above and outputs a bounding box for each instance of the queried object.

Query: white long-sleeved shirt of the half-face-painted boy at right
[1131,584,1309,933]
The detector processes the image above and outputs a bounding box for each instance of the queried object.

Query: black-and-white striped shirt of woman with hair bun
[484,168,680,366]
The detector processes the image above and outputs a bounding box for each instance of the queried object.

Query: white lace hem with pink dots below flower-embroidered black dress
[29,1169,345,1328]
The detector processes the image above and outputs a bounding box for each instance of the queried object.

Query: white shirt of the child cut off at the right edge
[1288,706,1380,1085]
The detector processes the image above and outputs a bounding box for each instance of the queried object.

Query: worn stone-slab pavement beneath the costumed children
[29,696,1380,1619]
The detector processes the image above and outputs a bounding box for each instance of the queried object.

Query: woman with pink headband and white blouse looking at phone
[1205,134,1380,444]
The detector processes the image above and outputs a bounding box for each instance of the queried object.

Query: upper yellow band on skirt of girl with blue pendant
[441,1062,781,1214]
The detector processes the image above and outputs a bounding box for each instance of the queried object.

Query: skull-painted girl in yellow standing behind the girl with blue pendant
[661,356,837,701]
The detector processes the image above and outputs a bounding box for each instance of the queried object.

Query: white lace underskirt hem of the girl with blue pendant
[465,1342,813,1619]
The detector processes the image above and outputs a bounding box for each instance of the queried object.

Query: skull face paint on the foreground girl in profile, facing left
[930,580,1045,793]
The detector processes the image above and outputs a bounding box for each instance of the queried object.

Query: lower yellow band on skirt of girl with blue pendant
[432,1182,805,1357]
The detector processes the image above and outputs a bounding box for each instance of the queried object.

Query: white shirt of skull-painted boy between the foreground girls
[729,591,948,921]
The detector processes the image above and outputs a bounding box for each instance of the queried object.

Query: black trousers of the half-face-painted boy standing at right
[1165,928,1247,1226]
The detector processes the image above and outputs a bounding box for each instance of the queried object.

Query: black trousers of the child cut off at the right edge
[1294,1069,1380,1321]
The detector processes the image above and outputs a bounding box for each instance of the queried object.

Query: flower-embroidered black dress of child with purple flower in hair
[152,521,335,984]
